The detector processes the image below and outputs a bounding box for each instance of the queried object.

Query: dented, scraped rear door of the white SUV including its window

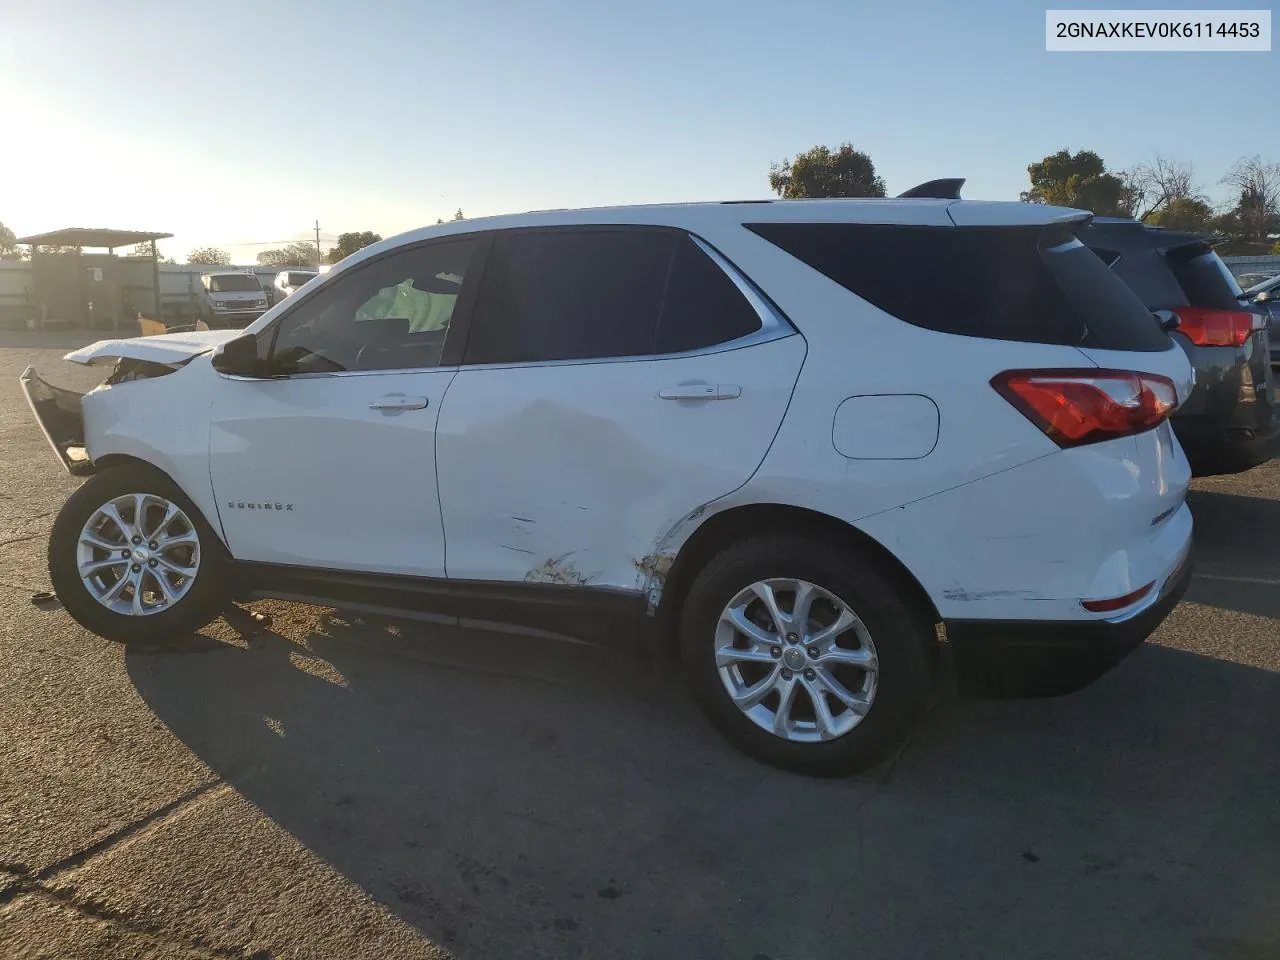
[436,230,805,590]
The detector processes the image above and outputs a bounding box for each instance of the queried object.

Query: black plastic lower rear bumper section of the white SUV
[947,553,1192,699]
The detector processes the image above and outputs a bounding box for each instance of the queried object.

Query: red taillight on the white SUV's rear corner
[991,370,1178,447]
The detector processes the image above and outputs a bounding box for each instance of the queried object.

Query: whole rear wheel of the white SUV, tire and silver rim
[680,534,933,777]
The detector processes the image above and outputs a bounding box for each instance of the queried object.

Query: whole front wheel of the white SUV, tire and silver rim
[49,463,229,644]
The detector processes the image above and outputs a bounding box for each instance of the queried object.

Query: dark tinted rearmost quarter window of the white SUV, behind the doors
[746,223,1170,351]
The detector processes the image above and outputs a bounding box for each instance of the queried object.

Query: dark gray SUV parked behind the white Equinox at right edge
[1079,216,1280,476]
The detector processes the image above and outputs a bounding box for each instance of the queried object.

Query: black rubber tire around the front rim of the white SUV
[49,463,229,643]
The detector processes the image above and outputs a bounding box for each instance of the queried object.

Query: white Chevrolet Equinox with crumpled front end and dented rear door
[23,185,1192,774]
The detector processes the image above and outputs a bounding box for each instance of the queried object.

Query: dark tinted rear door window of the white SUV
[465,229,762,364]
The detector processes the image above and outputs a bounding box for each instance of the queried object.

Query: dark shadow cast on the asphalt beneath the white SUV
[127,612,1280,960]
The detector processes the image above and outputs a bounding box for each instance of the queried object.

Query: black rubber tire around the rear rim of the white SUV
[680,538,931,776]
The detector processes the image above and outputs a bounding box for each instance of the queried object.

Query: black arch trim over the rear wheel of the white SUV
[657,503,941,641]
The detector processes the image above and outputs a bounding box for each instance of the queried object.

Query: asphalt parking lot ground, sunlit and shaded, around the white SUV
[0,333,1280,960]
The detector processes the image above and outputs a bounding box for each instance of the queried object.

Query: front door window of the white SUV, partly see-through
[269,238,480,375]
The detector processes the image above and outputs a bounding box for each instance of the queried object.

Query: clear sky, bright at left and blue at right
[0,0,1280,261]
